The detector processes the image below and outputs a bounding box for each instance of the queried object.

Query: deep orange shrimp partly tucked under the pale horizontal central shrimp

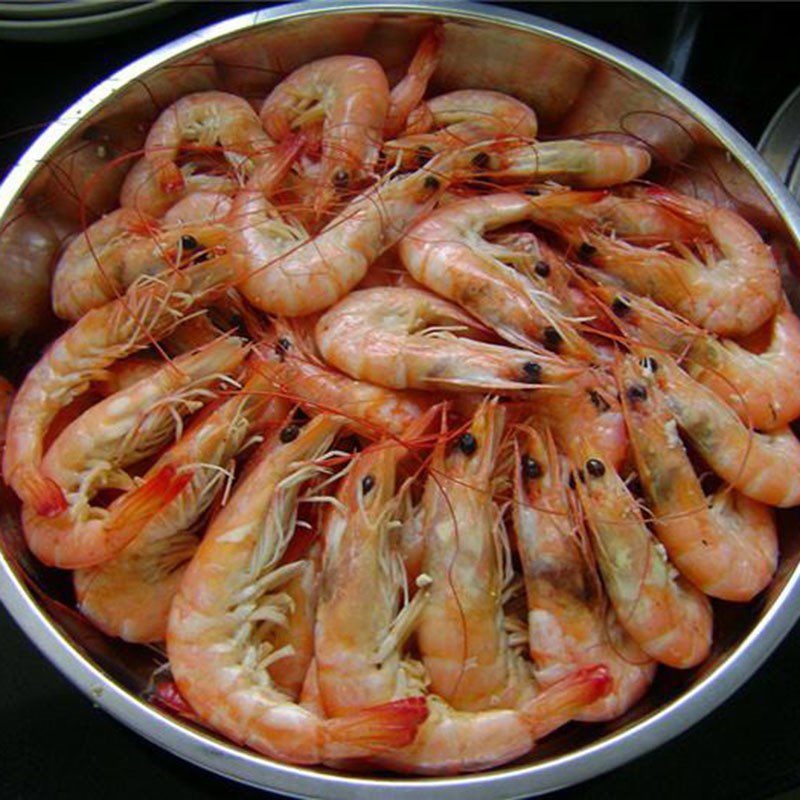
[259,319,430,438]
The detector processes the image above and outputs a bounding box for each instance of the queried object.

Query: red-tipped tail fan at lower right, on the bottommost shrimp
[522,665,613,739]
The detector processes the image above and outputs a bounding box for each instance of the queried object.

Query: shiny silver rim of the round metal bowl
[0,0,800,800]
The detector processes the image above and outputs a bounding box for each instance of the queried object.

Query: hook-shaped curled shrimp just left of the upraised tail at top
[261,56,390,212]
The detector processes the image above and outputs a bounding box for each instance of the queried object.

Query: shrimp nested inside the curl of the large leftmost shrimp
[42,337,247,519]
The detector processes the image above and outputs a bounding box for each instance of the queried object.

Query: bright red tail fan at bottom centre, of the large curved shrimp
[325,696,428,750]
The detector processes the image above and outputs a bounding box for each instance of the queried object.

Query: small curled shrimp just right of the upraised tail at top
[384,89,538,163]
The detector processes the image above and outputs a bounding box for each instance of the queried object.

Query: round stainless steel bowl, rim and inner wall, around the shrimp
[0,0,800,800]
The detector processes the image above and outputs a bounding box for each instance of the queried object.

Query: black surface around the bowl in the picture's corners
[0,3,800,800]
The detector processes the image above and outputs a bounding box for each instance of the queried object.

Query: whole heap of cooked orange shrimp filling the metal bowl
[0,28,800,775]
